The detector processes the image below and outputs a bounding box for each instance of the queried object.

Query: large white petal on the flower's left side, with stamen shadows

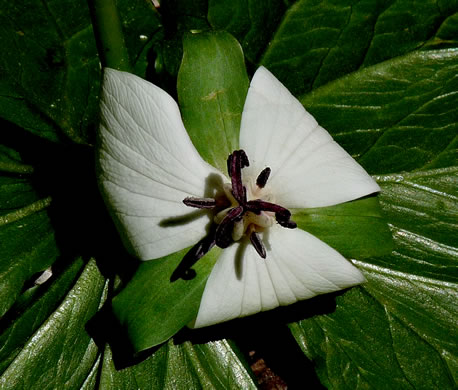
[98,69,222,260]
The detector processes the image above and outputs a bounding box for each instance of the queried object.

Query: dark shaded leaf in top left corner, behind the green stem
[0,0,159,143]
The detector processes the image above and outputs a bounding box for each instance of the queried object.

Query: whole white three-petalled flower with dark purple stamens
[98,67,380,327]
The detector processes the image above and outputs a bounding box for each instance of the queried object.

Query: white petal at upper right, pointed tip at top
[240,67,380,208]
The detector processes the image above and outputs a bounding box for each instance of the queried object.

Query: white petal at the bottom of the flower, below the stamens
[194,226,365,328]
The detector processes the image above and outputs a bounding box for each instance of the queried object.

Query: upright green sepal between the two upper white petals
[177,32,249,172]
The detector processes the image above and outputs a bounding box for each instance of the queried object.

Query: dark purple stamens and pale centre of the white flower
[171,150,297,281]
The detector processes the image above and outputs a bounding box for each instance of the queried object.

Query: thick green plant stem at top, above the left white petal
[88,0,131,71]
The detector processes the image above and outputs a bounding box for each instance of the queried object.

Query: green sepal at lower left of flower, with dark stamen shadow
[112,248,220,352]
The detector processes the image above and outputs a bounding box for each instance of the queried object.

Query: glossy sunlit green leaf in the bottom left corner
[0,261,106,389]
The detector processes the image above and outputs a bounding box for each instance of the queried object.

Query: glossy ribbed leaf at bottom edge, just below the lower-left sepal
[100,340,256,390]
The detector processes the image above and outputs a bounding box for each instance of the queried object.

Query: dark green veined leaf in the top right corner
[261,0,458,94]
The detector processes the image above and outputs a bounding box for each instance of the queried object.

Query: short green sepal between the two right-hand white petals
[292,197,393,259]
